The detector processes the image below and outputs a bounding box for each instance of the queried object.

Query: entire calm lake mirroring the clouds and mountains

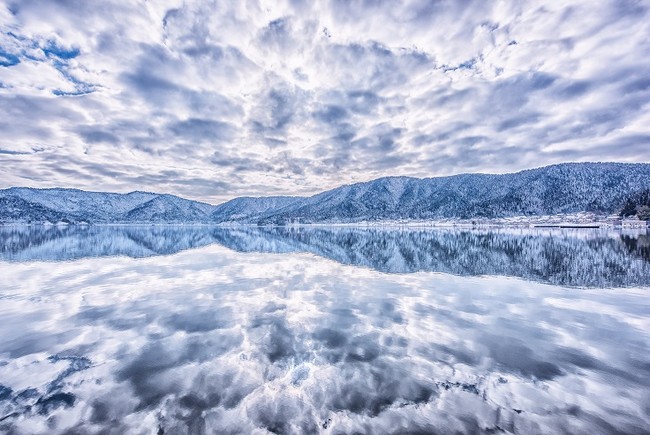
[0,226,650,434]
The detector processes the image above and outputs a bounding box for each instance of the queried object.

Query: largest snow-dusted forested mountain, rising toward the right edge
[251,163,650,224]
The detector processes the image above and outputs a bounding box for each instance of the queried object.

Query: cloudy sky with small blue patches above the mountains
[0,0,650,203]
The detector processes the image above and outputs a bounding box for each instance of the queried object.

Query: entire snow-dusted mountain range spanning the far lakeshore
[0,163,650,225]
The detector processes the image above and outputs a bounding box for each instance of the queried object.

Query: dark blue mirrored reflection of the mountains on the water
[0,226,650,287]
